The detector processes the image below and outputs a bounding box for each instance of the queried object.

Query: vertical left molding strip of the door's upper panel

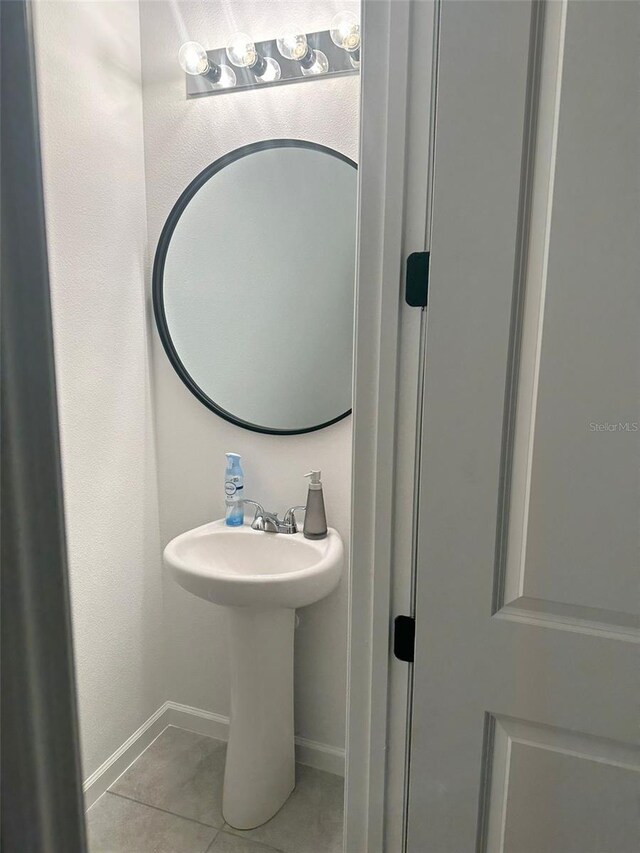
[493,0,567,613]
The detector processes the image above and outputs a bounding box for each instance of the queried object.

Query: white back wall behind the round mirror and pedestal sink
[141,0,359,746]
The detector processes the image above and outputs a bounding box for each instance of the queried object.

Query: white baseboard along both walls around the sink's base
[83,702,345,809]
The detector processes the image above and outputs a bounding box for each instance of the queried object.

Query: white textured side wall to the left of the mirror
[36,0,165,776]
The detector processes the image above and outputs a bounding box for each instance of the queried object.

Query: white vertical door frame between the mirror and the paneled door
[344,0,440,853]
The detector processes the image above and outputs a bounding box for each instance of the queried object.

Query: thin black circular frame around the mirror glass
[153,139,358,435]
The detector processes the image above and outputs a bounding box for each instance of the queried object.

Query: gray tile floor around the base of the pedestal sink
[87,726,343,853]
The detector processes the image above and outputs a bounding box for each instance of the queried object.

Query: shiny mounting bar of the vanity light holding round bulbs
[184,30,359,98]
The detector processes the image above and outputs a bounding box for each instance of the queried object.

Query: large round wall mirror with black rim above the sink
[153,140,357,434]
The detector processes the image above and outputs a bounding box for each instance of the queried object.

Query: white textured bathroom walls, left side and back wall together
[36,0,359,776]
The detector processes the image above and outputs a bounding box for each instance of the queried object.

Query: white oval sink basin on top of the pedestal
[164,520,343,608]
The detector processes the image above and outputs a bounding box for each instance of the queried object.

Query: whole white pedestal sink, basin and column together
[164,520,343,829]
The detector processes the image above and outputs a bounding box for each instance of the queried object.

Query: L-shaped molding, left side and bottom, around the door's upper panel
[492,0,640,643]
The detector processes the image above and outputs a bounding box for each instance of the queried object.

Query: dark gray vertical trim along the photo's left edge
[0,0,86,853]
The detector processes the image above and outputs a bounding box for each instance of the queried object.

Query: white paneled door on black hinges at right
[407,0,640,853]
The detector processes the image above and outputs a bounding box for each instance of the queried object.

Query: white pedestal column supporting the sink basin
[222,607,295,829]
